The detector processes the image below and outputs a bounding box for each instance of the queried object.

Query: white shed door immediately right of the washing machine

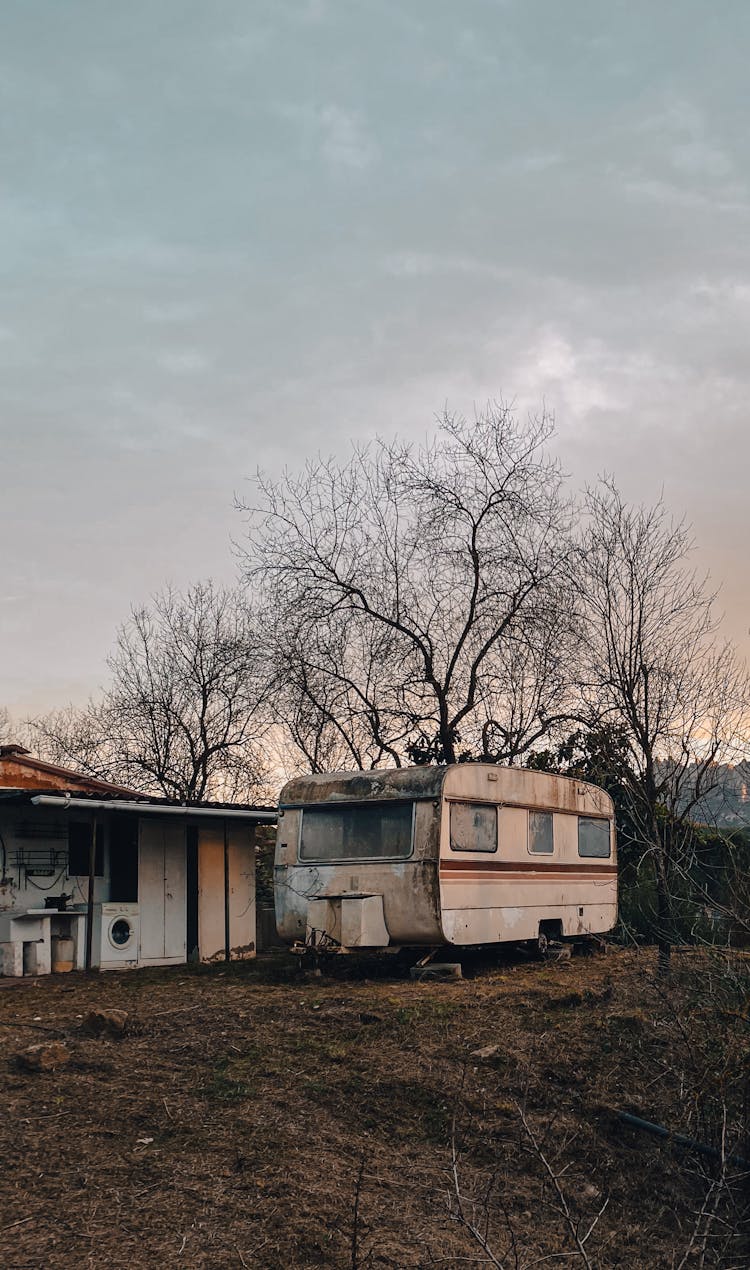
[138,819,188,964]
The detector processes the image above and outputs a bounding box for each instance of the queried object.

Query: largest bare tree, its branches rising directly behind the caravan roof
[244,405,569,766]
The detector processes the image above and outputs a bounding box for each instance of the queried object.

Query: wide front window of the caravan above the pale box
[299,803,412,864]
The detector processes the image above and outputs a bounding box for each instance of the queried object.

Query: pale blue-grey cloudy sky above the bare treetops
[0,0,750,719]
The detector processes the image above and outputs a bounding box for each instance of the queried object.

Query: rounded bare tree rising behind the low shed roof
[29,582,268,801]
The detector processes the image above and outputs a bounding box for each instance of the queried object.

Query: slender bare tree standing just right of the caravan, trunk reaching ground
[579,479,747,969]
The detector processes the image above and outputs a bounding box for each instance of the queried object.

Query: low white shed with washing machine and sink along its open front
[0,745,275,975]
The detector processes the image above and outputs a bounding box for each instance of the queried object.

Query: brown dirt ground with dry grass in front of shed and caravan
[0,951,750,1270]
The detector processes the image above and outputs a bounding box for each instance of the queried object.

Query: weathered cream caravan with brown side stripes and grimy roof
[274,763,617,951]
